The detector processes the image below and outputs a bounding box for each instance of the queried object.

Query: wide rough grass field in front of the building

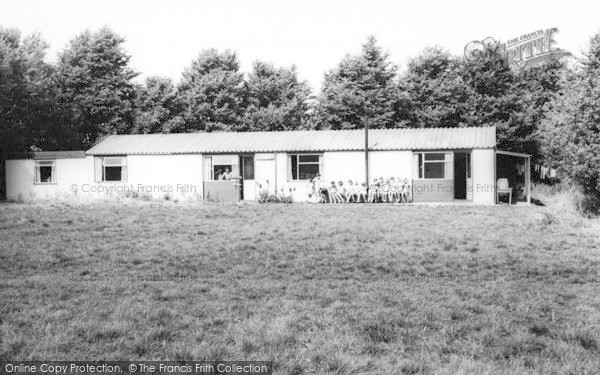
[0,202,600,374]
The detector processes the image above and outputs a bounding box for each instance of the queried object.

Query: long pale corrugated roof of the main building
[87,127,496,155]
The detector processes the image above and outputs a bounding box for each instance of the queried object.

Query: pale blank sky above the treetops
[0,0,600,92]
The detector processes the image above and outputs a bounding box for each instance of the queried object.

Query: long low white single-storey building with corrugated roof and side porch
[6,127,530,204]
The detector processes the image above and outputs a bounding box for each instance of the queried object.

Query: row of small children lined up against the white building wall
[311,175,412,203]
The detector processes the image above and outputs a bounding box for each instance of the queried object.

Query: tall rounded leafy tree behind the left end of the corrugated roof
[57,28,137,147]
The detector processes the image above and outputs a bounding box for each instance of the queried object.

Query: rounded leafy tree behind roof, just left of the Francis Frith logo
[399,47,473,128]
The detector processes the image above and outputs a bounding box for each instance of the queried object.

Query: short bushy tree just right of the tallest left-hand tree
[133,77,183,134]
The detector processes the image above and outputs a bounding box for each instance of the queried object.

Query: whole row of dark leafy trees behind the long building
[0,27,600,212]
